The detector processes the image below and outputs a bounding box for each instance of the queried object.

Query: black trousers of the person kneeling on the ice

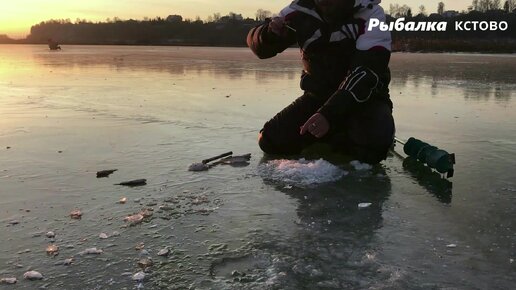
[259,92,395,164]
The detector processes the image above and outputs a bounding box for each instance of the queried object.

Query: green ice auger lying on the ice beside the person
[394,137,455,178]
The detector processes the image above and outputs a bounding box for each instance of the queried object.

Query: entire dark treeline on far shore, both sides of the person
[0,8,516,53]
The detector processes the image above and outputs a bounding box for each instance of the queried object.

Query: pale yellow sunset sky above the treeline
[0,0,471,38]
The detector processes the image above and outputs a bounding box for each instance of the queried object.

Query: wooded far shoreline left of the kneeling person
[5,13,259,46]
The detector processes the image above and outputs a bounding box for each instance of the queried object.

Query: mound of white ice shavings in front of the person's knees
[259,158,348,186]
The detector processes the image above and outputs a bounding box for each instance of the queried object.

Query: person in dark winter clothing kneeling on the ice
[247,0,395,164]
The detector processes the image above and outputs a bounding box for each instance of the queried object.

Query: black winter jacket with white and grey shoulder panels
[247,0,392,122]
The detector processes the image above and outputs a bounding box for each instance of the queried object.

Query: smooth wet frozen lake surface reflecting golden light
[0,46,516,289]
